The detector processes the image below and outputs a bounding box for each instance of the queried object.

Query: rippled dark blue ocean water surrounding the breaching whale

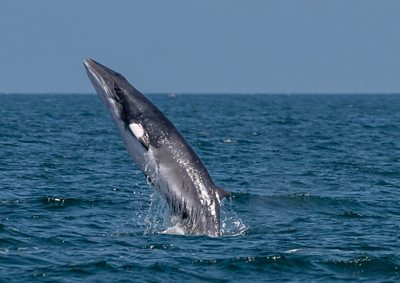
[0,94,400,282]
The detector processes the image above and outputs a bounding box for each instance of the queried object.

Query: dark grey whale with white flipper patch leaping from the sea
[84,59,229,237]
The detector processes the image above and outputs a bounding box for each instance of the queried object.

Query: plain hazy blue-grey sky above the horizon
[0,0,400,93]
